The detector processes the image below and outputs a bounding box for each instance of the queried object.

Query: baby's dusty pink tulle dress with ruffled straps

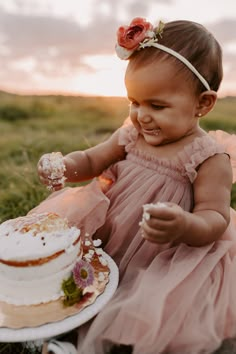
[31,124,236,354]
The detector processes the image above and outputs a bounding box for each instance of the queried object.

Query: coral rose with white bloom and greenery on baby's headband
[115,17,164,60]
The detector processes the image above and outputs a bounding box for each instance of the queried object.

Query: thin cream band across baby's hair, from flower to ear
[141,41,211,91]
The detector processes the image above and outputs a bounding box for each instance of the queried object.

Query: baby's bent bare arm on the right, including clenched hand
[142,154,232,246]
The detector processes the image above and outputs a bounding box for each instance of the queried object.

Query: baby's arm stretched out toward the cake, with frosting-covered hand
[38,131,125,189]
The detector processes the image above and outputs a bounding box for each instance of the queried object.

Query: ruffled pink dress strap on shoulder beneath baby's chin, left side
[119,117,138,152]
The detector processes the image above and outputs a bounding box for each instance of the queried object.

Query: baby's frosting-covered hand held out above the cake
[38,152,66,190]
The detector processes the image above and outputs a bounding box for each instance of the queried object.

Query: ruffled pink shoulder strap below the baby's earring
[180,135,225,183]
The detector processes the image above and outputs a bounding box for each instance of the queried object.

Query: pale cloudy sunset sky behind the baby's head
[0,0,236,96]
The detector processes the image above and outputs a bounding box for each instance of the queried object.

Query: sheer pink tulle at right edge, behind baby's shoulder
[209,130,236,183]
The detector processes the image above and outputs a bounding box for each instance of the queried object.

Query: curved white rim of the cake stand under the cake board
[0,252,119,343]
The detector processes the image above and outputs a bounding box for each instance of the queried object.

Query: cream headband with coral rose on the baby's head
[115,17,211,90]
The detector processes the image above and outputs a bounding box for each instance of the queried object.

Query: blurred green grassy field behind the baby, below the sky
[0,92,236,354]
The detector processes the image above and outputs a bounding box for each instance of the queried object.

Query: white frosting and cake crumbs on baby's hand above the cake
[42,152,66,190]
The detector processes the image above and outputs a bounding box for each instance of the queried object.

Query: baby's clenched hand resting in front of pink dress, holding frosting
[140,203,186,243]
